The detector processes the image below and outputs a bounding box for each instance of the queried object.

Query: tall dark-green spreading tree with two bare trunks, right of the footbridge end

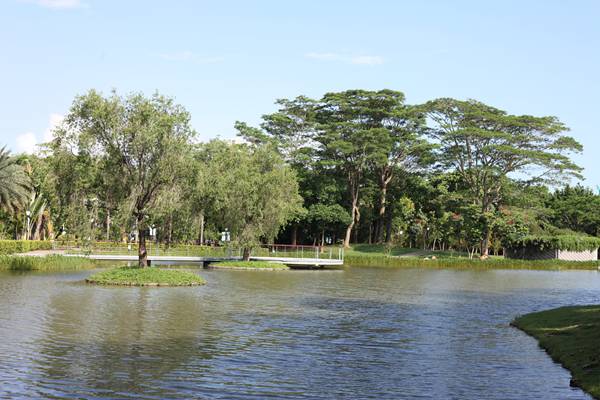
[315,90,429,247]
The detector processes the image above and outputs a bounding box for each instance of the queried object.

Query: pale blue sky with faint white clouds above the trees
[0,0,600,186]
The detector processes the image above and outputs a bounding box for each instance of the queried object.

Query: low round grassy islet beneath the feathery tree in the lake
[86,267,206,286]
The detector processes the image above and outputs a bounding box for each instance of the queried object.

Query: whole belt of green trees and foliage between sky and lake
[0,90,600,256]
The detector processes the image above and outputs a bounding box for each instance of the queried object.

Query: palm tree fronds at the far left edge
[0,147,31,213]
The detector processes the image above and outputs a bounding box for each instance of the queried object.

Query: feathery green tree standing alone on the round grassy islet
[55,90,195,267]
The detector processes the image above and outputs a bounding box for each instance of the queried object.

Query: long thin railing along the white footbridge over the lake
[54,242,344,260]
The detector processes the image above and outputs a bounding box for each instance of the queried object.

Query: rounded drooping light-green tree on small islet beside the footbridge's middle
[200,140,302,260]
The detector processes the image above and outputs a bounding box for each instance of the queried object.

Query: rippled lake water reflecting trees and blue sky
[0,268,600,400]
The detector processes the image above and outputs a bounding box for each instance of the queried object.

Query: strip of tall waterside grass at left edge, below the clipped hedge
[0,255,96,271]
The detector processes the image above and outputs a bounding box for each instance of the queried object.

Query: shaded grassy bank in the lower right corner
[511,305,600,399]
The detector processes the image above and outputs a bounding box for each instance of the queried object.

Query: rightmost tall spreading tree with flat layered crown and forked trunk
[425,98,582,256]
